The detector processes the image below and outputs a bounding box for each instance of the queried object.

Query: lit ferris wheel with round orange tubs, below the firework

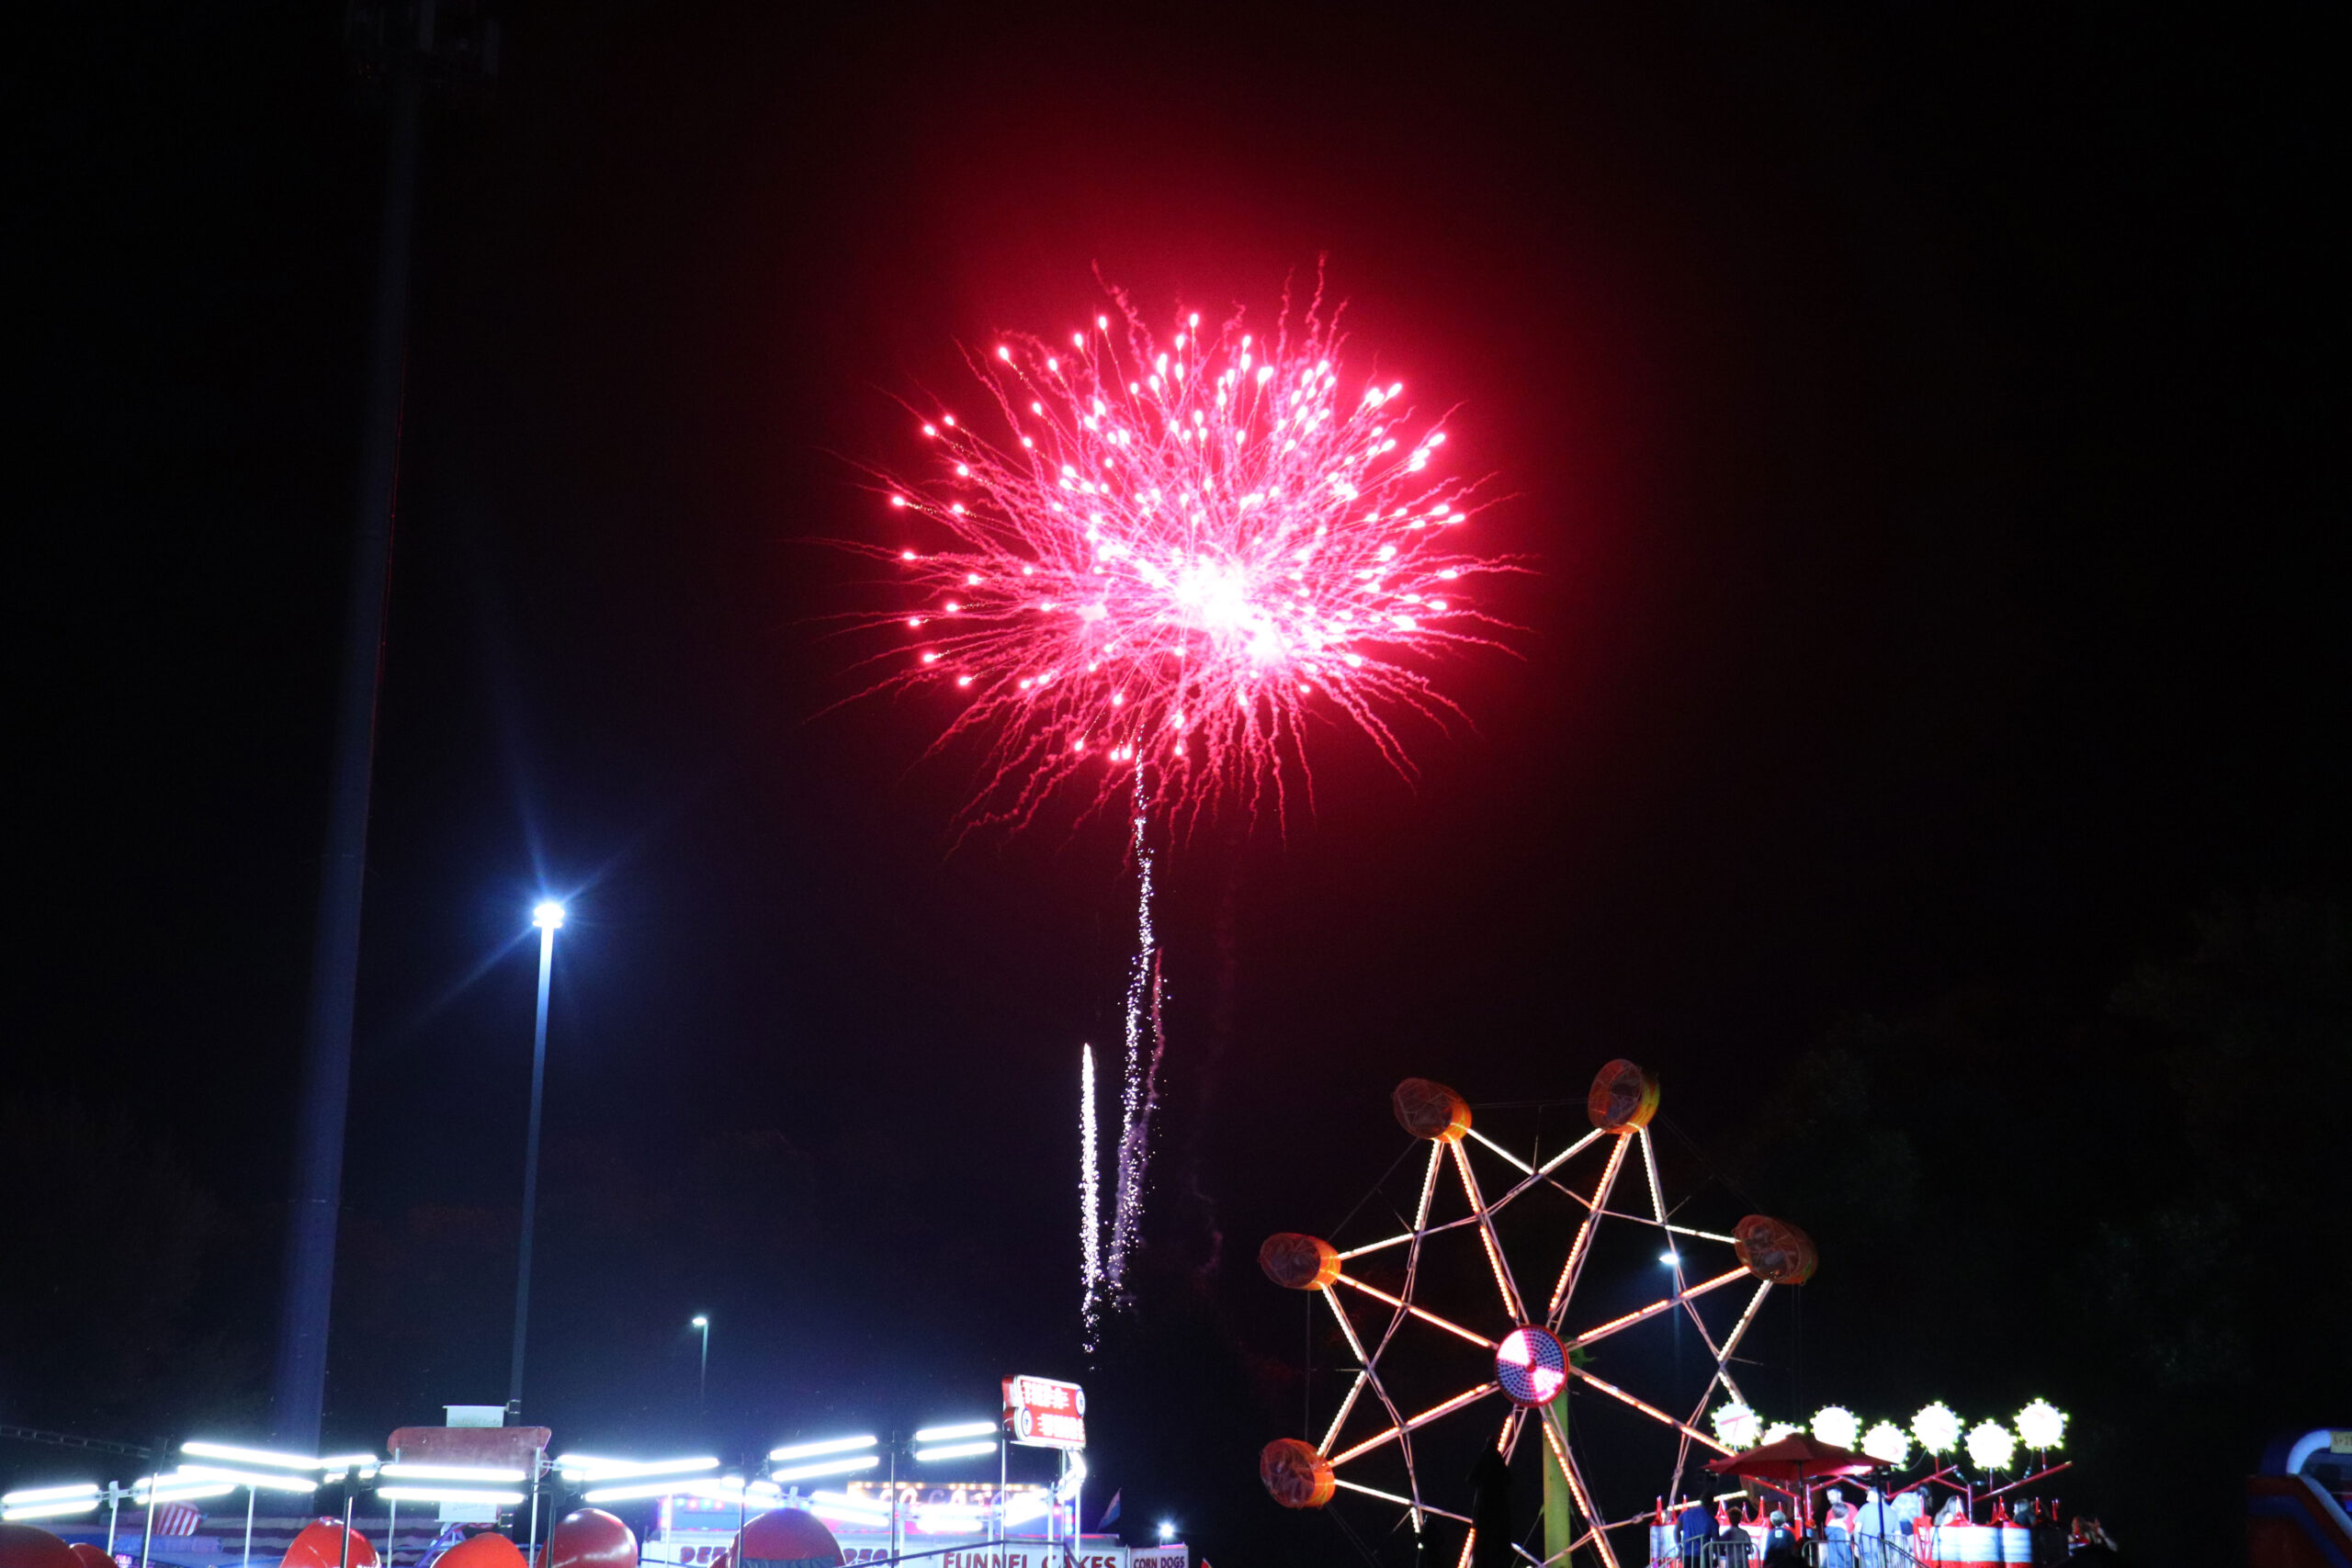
[1259,1060,1815,1568]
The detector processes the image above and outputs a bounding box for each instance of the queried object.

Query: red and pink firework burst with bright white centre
[873,287,1512,825]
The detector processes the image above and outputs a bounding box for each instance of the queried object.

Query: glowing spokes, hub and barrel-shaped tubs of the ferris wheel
[1259,1060,1815,1568]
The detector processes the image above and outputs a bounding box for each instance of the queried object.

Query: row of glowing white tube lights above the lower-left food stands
[0,1420,1044,1523]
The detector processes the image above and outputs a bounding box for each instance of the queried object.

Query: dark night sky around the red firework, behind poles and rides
[0,3,2352,1568]
